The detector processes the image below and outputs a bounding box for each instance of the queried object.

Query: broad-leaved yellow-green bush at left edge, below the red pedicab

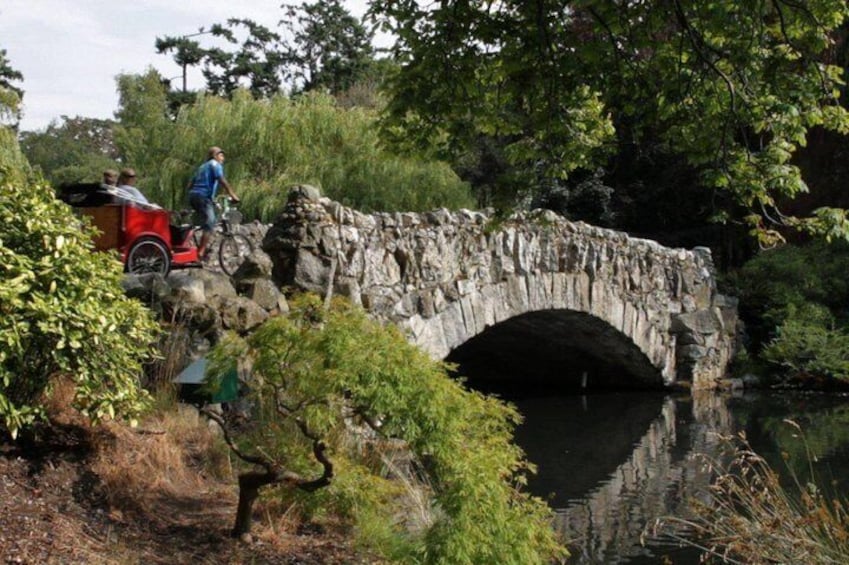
[0,159,157,436]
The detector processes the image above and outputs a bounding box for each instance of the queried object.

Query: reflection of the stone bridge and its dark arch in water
[500,393,733,564]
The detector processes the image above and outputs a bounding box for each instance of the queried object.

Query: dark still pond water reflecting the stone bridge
[494,392,849,565]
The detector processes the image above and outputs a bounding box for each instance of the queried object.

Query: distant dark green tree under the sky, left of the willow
[20,116,119,186]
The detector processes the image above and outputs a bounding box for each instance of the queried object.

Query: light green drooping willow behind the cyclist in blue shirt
[116,73,472,215]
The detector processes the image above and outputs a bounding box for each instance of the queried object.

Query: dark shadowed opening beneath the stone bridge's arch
[446,309,664,391]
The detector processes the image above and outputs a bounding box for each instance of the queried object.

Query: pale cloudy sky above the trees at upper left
[0,0,366,131]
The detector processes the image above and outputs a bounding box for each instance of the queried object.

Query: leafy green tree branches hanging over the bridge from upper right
[371,0,849,240]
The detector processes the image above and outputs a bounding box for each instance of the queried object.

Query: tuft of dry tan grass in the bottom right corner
[664,421,849,565]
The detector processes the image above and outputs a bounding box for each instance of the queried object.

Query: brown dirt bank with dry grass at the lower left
[0,414,368,565]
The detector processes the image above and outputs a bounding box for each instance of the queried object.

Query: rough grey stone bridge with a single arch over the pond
[263,187,737,388]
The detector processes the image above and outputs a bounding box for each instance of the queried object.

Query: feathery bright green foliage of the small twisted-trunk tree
[205,296,563,564]
